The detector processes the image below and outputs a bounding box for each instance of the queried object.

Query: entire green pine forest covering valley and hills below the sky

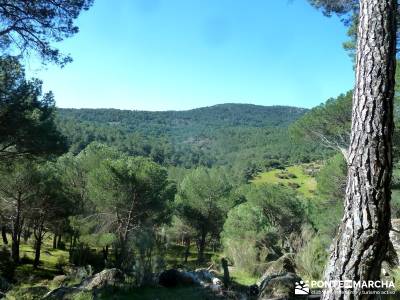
[0,58,400,299]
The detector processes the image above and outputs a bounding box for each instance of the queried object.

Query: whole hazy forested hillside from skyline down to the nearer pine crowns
[57,104,323,175]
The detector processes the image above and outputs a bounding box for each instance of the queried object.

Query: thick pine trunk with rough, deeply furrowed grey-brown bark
[322,0,397,300]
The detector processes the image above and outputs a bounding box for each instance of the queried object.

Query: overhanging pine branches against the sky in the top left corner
[0,0,93,65]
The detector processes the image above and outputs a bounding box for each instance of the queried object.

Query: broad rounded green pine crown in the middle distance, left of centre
[88,157,175,231]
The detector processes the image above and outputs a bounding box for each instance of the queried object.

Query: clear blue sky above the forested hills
[28,0,354,110]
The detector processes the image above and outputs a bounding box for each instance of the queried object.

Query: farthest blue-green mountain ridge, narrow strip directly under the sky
[58,103,307,137]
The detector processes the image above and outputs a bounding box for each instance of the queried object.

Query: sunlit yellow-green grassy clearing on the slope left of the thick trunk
[253,164,318,197]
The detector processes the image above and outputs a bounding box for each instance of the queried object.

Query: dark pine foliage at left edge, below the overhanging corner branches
[0,56,66,159]
